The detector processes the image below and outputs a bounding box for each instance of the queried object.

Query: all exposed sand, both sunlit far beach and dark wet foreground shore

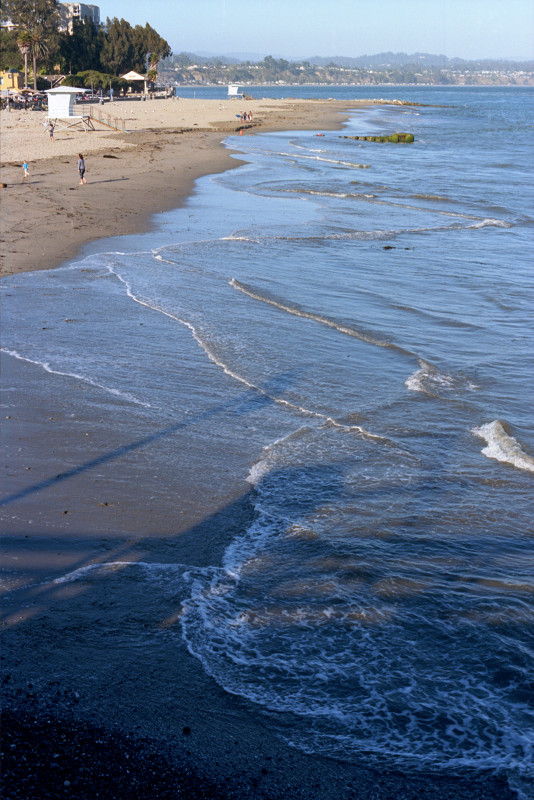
[0,99,515,800]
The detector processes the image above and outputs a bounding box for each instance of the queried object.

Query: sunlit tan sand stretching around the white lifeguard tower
[0,98,361,275]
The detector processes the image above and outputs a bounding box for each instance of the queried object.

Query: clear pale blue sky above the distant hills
[98,0,534,60]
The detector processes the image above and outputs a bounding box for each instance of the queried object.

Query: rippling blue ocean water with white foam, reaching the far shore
[2,87,534,796]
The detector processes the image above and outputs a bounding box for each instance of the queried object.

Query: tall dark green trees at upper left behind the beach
[0,0,171,89]
